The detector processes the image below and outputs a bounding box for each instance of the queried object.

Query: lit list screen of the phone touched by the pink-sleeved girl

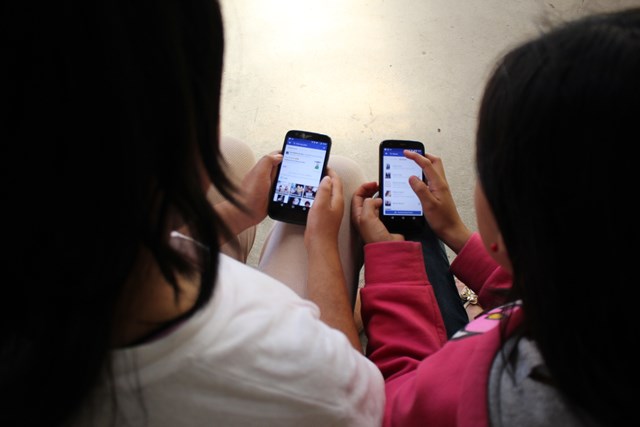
[381,147,424,221]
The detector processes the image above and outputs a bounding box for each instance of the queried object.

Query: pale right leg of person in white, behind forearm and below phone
[258,155,366,305]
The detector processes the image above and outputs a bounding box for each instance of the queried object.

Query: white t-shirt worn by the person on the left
[77,255,384,427]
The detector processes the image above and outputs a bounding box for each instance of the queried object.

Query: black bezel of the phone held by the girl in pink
[378,139,426,234]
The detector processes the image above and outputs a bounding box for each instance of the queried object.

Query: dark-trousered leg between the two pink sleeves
[405,224,469,337]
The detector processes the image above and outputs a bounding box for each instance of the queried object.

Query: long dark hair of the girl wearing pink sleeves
[476,9,640,425]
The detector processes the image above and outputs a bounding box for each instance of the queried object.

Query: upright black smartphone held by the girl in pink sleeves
[378,140,426,234]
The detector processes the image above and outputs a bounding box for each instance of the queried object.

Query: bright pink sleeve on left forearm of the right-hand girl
[361,242,447,426]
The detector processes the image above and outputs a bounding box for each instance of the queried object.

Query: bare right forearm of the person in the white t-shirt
[307,241,362,352]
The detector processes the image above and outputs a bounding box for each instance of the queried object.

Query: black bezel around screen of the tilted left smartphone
[268,129,332,225]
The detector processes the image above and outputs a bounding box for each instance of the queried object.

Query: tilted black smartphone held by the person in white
[268,130,331,225]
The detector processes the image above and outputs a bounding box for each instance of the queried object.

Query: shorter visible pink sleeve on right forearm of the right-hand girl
[451,233,512,309]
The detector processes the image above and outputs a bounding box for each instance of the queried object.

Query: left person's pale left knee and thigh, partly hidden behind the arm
[207,137,256,262]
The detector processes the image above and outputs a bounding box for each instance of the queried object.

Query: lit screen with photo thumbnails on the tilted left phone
[272,136,330,220]
